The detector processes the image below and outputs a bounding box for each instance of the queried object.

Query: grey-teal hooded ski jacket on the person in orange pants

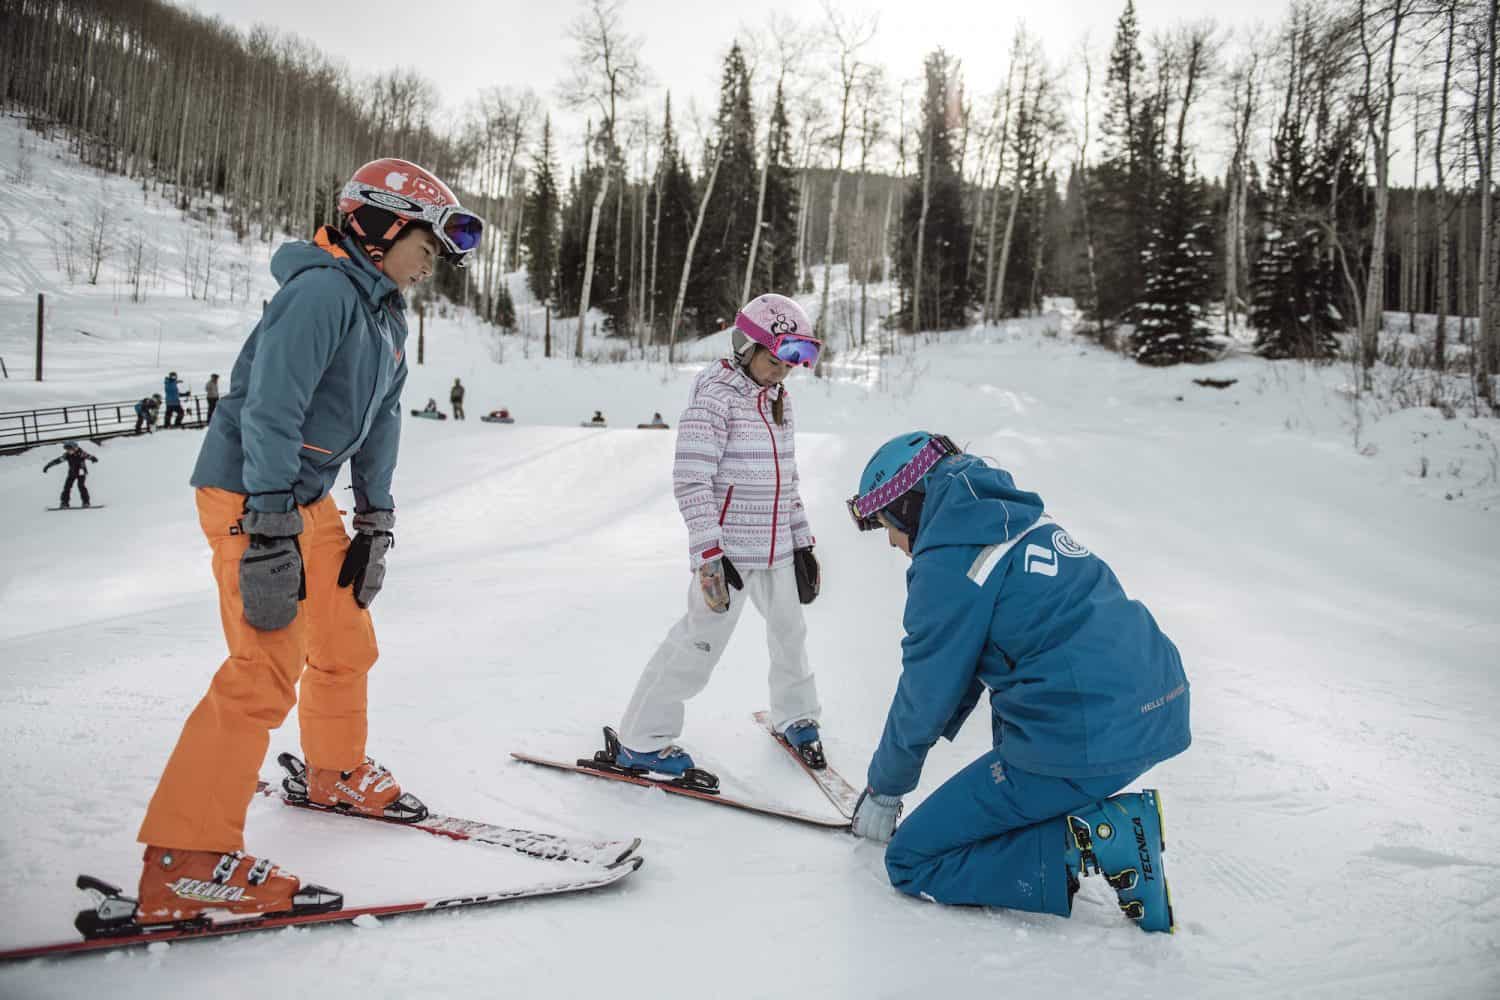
[192,226,407,513]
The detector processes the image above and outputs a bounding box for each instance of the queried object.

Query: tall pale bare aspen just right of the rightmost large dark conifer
[1358,0,1413,378]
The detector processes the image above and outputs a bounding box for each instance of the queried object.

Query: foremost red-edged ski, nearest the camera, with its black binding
[0,858,644,961]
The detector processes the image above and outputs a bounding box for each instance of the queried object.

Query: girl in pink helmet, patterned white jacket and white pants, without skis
[617,295,827,777]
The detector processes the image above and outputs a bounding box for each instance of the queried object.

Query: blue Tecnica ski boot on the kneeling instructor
[1067,789,1173,934]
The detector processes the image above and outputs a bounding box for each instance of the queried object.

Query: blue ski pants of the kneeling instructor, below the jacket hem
[885,750,1140,916]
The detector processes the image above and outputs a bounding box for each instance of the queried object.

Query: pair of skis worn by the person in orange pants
[0,754,644,961]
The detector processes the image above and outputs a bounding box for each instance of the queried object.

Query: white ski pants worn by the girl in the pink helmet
[620,562,822,751]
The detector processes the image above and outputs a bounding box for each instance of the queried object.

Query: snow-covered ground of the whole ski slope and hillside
[0,111,1500,1000]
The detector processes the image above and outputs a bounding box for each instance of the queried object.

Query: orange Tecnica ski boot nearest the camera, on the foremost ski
[135,847,344,925]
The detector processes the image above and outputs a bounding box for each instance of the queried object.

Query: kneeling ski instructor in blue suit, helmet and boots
[849,432,1191,931]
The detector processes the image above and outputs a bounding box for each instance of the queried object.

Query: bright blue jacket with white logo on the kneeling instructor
[869,454,1191,795]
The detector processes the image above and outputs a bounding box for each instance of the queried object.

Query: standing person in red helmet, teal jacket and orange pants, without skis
[137,159,482,924]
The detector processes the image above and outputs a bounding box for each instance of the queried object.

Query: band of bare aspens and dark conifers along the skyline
[0,0,1500,399]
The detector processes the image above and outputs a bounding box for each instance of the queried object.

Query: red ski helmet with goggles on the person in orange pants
[339,157,485,267]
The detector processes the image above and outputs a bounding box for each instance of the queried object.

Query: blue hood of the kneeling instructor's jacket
[912,454,1046,556]
